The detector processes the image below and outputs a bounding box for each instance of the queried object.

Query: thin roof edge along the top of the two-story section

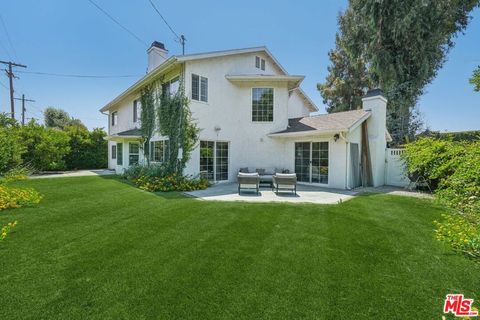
[100,46,318,112]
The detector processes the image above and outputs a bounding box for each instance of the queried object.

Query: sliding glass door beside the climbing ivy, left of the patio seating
[200,141,229,181]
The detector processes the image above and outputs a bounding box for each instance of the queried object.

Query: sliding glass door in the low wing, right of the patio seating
[295,142,328,184]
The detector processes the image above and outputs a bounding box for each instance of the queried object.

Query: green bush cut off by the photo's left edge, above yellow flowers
[0,115,25,175]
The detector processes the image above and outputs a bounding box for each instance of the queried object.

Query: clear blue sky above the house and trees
[0,0,480,131]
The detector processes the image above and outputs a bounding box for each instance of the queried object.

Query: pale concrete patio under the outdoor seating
[185,183,358,204]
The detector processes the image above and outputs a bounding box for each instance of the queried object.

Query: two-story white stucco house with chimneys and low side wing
[100,42,389,189]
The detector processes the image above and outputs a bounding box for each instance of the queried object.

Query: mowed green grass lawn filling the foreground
[0,177,480,320]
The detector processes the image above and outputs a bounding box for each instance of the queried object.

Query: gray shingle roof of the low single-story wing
[272,109,370,135]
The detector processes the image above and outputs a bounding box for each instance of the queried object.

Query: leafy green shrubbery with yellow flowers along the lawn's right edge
[404,138,480,257]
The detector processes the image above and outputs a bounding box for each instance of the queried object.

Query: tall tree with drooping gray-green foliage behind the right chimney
[319,0,479,144]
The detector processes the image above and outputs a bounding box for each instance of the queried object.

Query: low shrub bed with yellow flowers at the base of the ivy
[133,174,209,192]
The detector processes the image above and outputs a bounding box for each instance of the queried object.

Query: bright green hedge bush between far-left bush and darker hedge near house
[20,120,70,171]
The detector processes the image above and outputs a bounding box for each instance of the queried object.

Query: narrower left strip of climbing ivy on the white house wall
[140,84,157,164]
